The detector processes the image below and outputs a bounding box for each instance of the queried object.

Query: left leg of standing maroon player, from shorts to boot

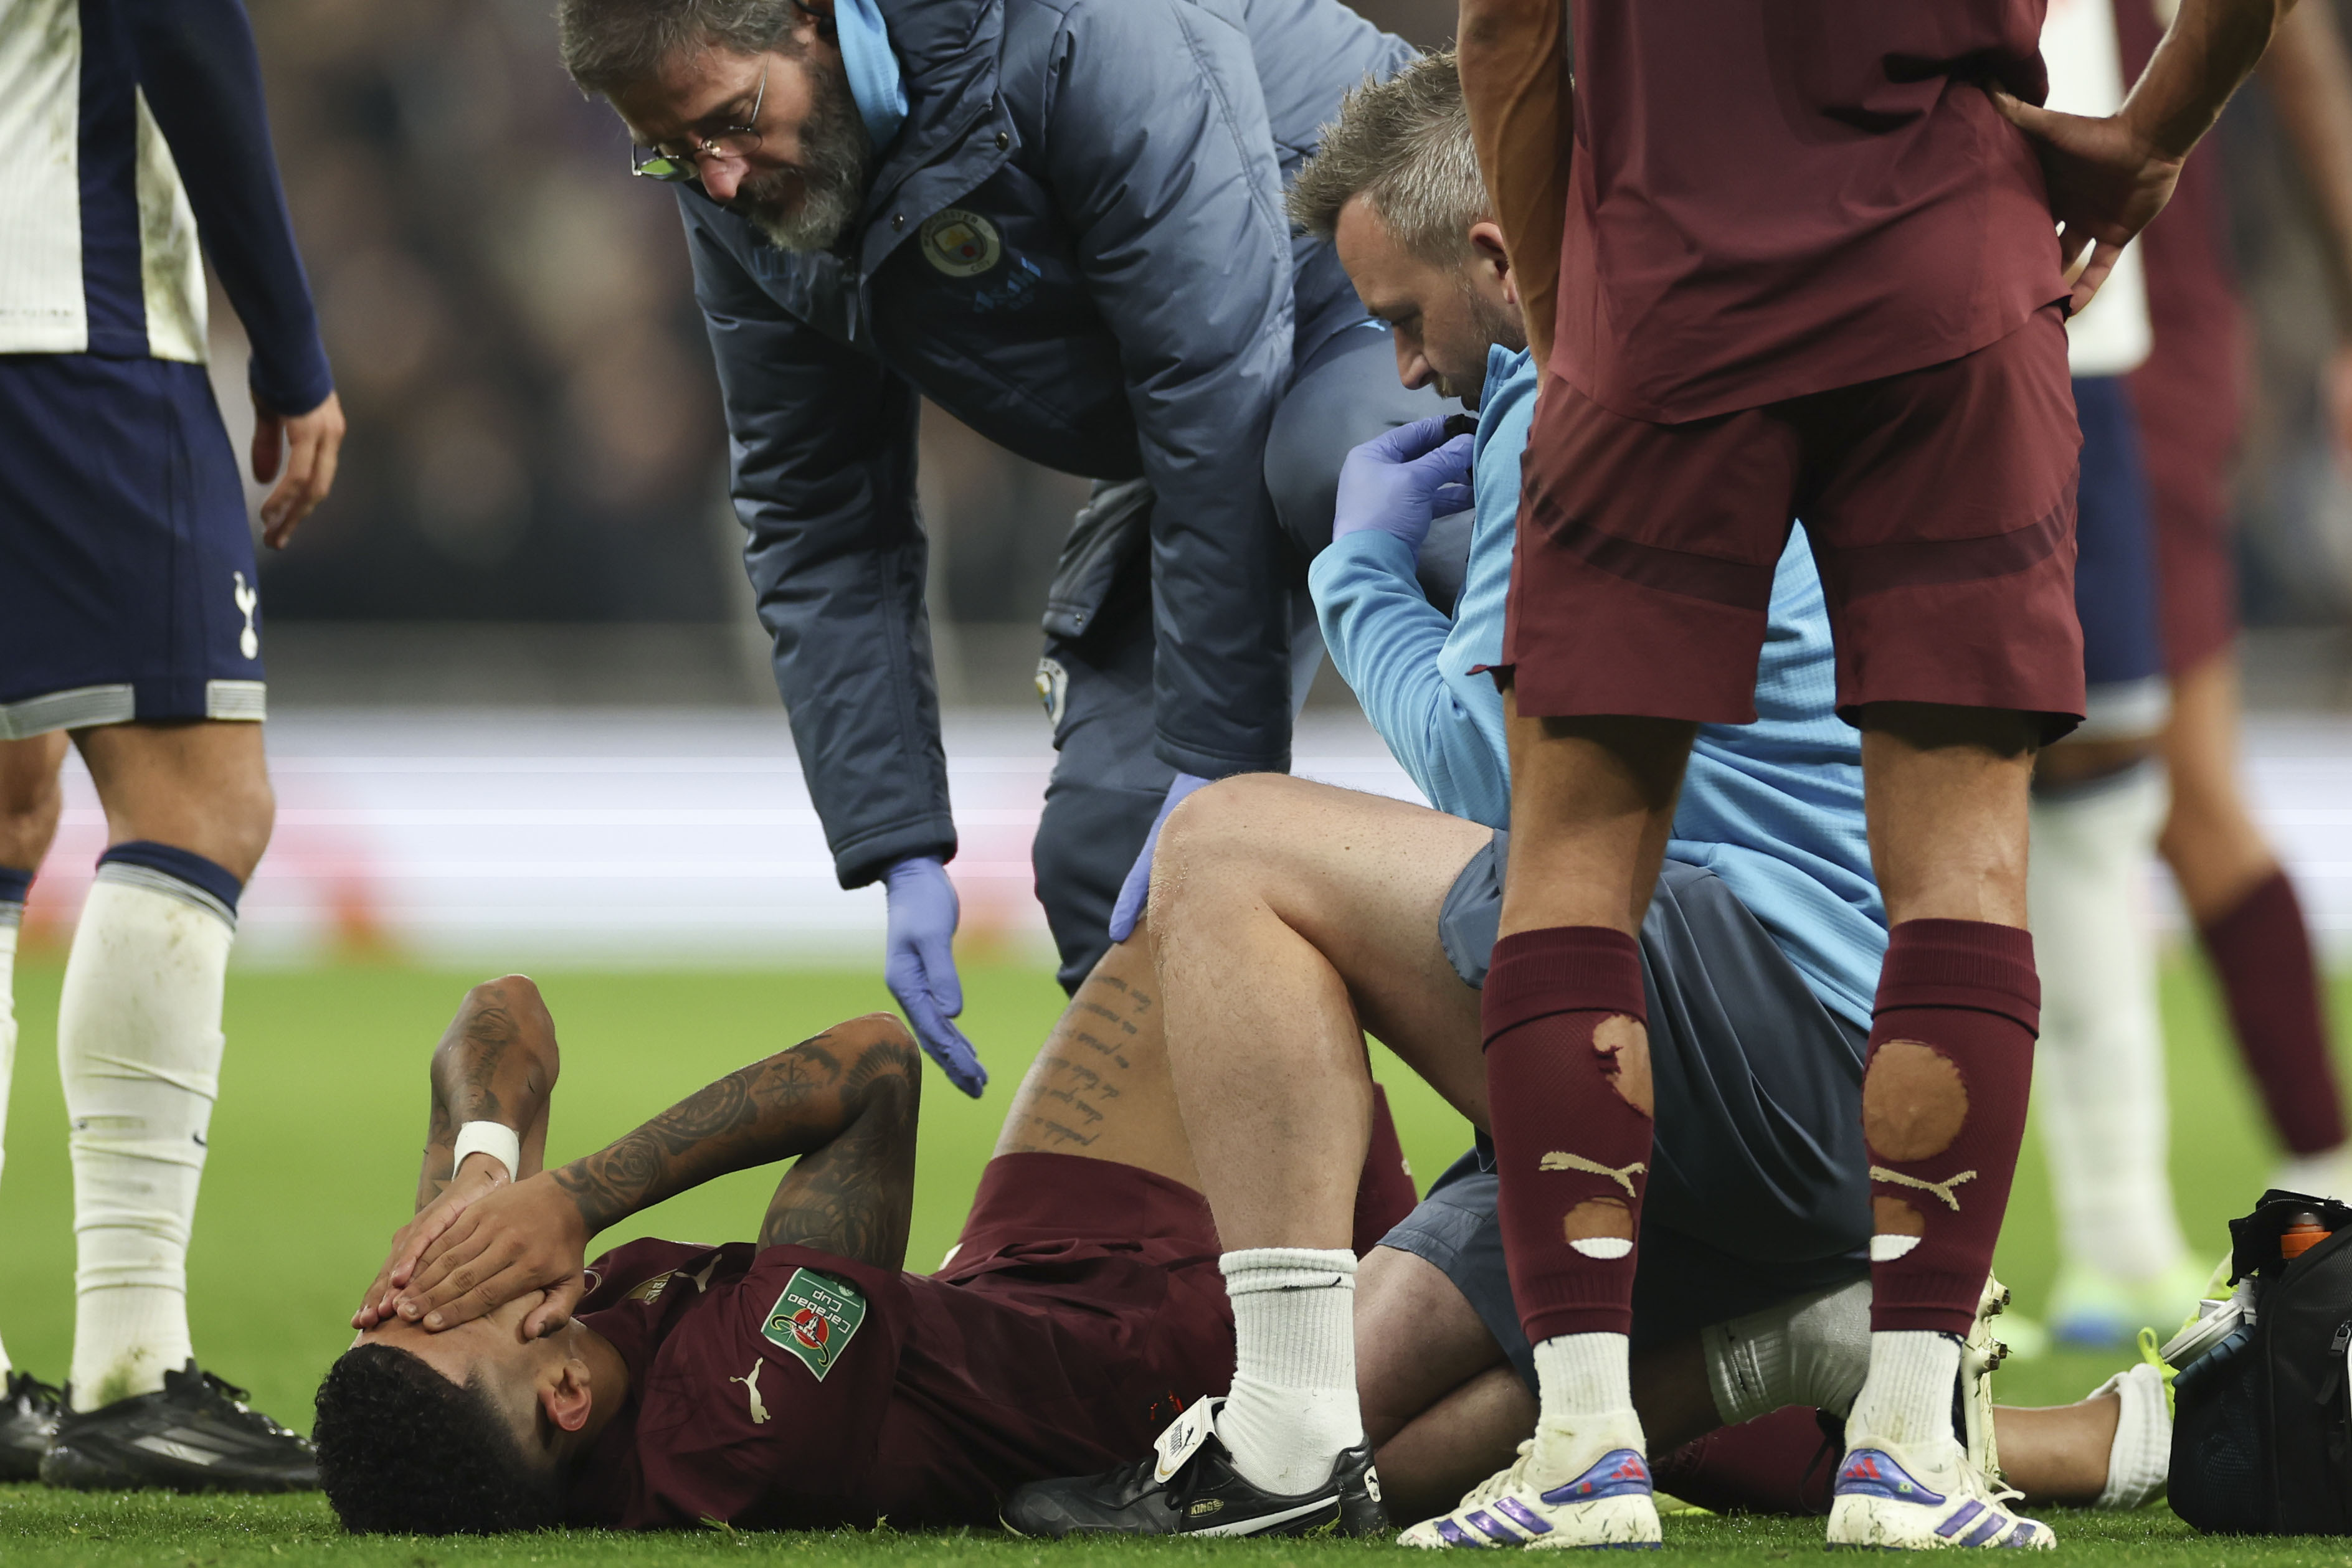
[1413,376,1800,1544]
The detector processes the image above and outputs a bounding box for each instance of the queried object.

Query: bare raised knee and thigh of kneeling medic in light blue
[1152,773,1494,1126]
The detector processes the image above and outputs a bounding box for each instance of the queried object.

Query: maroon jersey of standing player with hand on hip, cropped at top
[1550,0,2065,423]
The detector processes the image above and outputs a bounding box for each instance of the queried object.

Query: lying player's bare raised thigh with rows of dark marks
[995,926,1200,1189]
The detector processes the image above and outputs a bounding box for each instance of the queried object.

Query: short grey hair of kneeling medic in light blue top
[1286,49,1491,263]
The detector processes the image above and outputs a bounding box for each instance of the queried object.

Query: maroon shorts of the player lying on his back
[936,1155,1233,1453]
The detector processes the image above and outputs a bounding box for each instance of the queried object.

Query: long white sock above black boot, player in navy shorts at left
[57,862,235,1410]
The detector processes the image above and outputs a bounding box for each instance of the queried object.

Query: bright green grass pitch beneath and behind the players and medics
[0,961,2352,1568]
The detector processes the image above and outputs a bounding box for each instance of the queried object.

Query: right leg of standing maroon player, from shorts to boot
[1792,308,2084,1547]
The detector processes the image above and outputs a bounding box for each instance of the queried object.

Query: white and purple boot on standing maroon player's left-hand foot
[1397,1417,1658,1549]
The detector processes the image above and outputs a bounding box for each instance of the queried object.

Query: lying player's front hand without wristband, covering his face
[395,1171,588,1338]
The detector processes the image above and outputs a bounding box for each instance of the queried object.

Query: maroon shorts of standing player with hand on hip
[1503,306,2084,738]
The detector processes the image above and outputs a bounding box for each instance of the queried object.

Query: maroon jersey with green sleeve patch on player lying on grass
[569,1156,1233,1528]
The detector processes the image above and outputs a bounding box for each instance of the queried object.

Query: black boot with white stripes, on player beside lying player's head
[40,1361,318,1493]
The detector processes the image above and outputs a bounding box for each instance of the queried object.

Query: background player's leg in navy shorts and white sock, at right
[2027,376,2204,1347]
